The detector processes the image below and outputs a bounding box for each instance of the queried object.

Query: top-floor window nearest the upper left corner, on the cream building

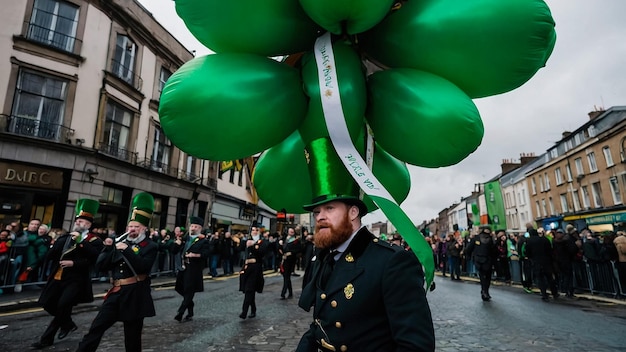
[26,0,78,53]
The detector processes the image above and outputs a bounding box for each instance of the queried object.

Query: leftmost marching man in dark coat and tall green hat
[32,199,102,349]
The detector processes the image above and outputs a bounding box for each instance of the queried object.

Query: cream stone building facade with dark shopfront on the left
[0,0,236,233]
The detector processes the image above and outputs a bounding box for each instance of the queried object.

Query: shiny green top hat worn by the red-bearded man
[303,138,368,216]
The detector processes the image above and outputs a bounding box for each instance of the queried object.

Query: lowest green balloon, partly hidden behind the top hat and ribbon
[252,131,411,214]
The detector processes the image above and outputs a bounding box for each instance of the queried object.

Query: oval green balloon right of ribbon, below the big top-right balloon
[366,68,484,167]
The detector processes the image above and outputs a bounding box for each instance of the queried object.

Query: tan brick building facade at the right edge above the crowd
[526,106,626,232]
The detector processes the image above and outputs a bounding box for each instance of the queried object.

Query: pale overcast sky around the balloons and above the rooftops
[139,0,626,224]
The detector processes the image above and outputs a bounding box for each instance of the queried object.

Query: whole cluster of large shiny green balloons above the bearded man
[159,0,556,213]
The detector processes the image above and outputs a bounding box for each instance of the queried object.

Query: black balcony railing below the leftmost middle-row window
[0,115,74,143]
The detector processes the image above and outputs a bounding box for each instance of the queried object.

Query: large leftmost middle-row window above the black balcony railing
[9,71,68,141]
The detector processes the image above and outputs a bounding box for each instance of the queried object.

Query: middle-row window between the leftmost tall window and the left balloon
[100,99,133,161]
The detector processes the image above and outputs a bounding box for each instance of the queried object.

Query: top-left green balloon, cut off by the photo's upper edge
[176,0,319,56]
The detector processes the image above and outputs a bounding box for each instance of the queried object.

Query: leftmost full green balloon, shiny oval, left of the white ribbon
[159,53,306,160]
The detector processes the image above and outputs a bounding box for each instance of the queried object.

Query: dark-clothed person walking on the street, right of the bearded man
[465,225,497,301]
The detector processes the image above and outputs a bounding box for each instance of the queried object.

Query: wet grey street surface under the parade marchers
[0,275,626,352]
